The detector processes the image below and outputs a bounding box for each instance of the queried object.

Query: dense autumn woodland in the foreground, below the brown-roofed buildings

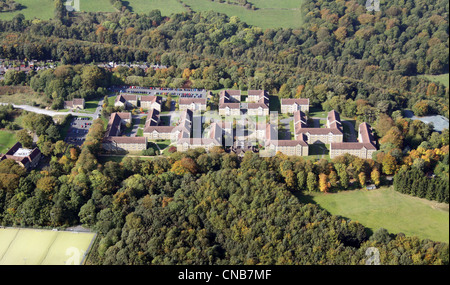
[0,114,448,264]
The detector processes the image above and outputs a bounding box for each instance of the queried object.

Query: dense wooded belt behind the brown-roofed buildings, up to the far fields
[0,0,449,117]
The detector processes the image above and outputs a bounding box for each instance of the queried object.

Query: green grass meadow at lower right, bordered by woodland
[299,187,449,242]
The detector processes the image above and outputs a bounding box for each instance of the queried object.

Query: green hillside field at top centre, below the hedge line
[181,0,302,29]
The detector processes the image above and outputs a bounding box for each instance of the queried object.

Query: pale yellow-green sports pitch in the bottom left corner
[0,228,96,265]
